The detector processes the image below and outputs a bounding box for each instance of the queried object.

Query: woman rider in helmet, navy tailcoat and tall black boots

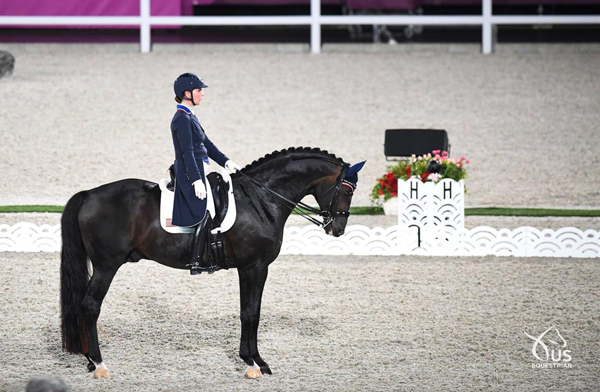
[171,73,240,275]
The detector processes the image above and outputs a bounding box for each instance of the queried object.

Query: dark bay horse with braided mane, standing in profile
[60,147,360,378]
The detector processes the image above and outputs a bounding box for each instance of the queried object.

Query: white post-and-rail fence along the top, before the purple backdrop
[0,0,600,54]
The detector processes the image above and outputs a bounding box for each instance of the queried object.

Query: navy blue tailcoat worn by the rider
[171,105,229,226]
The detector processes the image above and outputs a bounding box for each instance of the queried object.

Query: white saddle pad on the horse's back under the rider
[158,159,236,234]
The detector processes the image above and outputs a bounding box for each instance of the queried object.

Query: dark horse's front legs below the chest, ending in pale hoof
[238,266,271,378]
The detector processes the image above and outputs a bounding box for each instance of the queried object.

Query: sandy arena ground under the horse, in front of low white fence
[0,253,600,391]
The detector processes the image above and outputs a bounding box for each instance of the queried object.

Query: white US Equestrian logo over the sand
[525,326,573,369]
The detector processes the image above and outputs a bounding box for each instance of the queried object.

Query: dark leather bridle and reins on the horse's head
[237,157,355,229]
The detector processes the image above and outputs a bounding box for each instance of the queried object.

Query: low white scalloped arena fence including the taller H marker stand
[0,177,600,257]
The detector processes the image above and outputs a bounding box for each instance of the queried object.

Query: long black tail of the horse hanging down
[60,191,89,354]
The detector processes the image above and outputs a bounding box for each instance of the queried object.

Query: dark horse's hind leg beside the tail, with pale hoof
[82,266,119,378]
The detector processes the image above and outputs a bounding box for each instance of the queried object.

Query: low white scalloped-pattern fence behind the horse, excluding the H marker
[0,222,600,258]
